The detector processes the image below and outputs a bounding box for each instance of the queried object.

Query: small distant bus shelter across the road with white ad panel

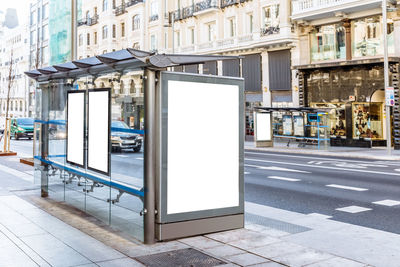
[254,107,331,149]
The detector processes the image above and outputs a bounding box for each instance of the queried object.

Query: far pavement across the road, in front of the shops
[245,141,400,160]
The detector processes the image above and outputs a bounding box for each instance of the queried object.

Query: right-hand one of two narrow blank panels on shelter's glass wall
[87,89,110,174]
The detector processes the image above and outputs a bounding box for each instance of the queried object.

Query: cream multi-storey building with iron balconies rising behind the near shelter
[78,0,299,135]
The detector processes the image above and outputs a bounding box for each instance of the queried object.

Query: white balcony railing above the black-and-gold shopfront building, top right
[292,0,382,15]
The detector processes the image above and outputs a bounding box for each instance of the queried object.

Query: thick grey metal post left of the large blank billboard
[143,69,157,244]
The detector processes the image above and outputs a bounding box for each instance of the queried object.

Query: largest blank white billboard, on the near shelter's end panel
[167,80,240,214]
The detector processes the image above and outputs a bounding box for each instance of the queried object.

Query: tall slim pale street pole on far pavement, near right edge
[382,0,392,155]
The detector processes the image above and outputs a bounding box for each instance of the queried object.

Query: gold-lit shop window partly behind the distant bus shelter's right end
[311,103,346,137]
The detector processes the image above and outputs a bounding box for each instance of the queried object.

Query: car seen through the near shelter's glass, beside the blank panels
[111,121,142,152]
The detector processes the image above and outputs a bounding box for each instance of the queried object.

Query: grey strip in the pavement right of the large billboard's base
[245,213,312,234]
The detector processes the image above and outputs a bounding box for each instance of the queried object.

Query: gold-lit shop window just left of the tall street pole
[352,103,383,139]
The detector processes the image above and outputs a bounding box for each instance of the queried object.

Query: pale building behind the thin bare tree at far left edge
[0,18,29,118]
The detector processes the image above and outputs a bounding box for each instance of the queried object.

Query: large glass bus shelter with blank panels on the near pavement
[26,49,244,244]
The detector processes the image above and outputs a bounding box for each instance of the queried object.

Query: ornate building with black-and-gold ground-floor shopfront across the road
[292,0,400,149]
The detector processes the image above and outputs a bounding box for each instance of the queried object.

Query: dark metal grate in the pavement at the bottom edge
[135,248,226,267]
